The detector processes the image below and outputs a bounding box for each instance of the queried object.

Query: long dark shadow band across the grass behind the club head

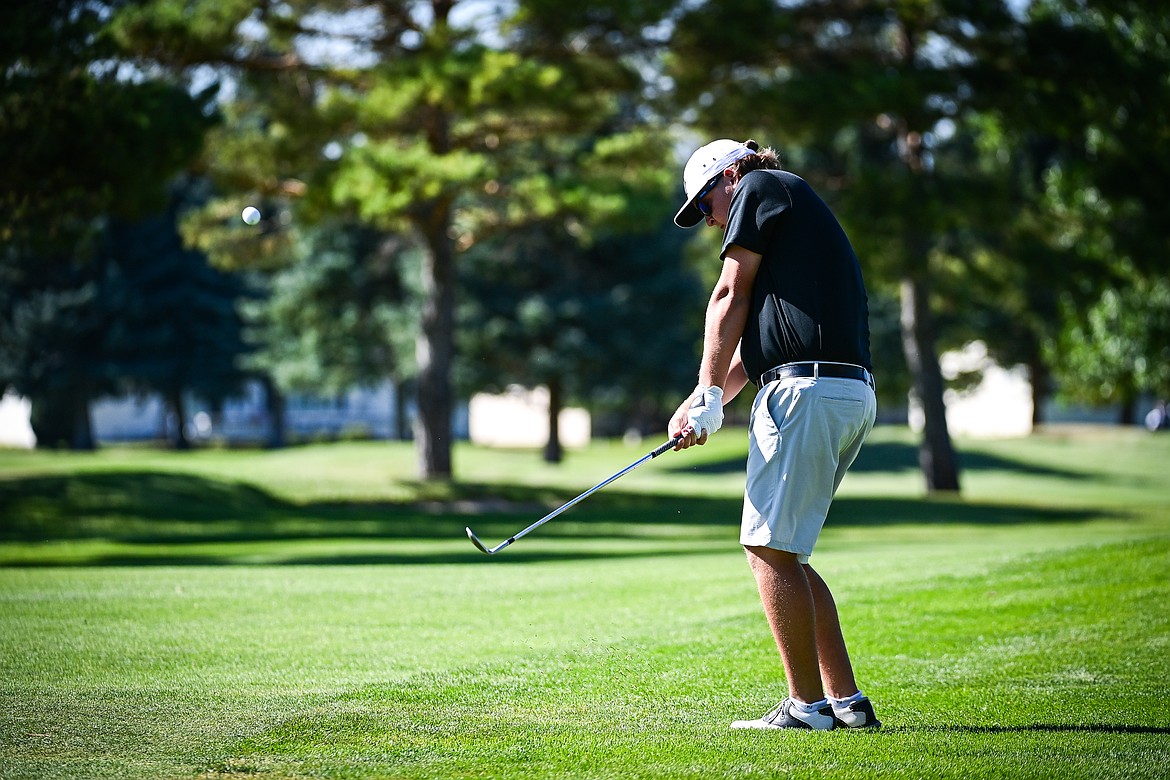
[0,471,1121,566]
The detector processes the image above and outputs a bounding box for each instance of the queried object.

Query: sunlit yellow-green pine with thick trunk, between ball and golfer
[115,0,669,478]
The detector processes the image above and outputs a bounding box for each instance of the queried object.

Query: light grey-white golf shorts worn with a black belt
[739,377,878,564]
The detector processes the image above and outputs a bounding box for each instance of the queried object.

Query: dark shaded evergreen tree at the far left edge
[0,0,213,448]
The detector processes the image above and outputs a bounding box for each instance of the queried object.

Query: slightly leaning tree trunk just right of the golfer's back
[901,277,959,492]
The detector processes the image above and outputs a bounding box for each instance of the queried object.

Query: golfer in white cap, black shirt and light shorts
[669,139,880,730]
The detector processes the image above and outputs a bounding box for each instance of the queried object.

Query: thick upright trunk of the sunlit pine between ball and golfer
[414,202,455,479]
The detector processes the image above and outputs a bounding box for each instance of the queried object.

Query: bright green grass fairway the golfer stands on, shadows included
[0,428,1170,780]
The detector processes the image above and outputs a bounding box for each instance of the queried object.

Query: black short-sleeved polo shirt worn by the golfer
[721,171,873,381]
